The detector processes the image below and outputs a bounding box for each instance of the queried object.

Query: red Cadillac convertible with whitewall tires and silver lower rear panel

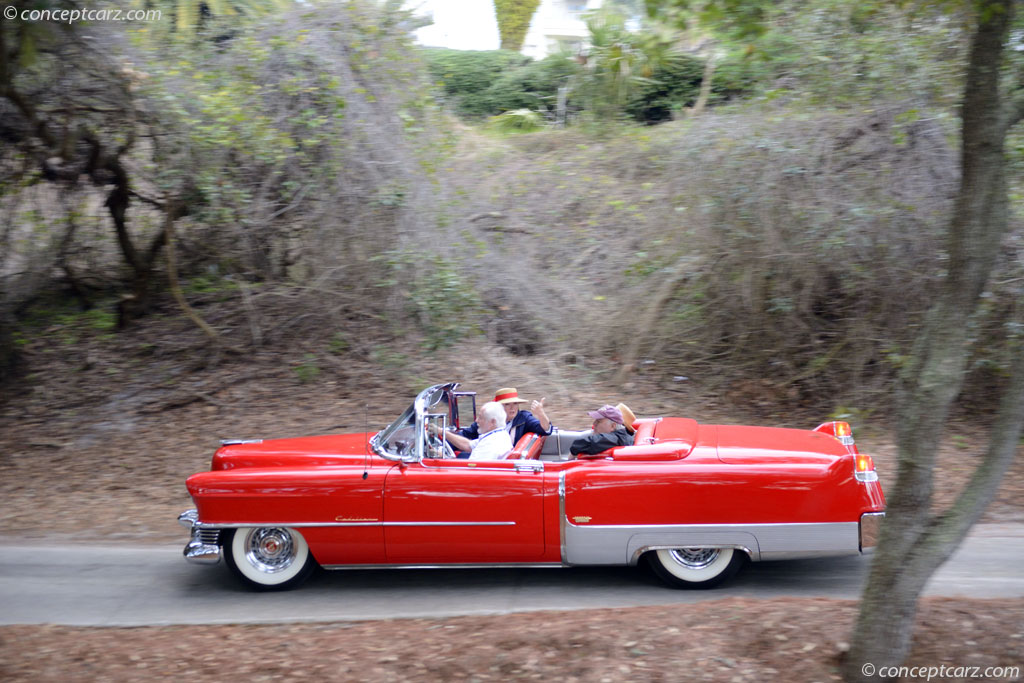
[179,383,885,590]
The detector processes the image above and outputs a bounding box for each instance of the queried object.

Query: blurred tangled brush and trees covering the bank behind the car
[0,0,1024,414]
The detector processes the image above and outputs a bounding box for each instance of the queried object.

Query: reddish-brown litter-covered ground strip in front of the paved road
[0,598,1024,683]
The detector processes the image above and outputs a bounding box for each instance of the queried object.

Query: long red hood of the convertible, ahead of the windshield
[210,432,374,470]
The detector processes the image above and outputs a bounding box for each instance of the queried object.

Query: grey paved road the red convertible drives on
[0,524,1024,626]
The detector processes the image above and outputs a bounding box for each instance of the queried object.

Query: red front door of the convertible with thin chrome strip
[384,460,544,564]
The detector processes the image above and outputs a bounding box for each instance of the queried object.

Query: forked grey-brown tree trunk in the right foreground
[843,0,1024,681]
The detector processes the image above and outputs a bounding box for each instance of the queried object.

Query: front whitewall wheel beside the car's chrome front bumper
[224,526,316,591]
